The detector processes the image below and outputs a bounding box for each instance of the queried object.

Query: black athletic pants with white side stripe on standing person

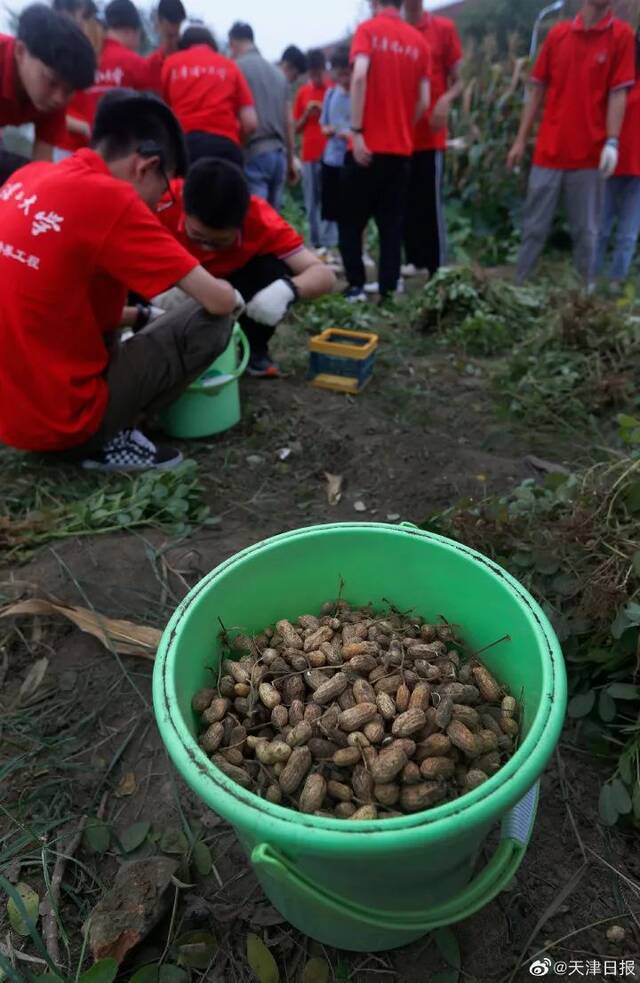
[404,150,447,274]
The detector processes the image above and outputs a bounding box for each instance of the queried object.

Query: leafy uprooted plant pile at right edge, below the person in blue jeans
[496,294,640,431]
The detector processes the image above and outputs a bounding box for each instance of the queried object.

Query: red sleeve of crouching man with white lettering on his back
[98,200,198,297]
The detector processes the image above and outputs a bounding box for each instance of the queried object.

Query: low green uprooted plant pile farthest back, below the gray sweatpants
[410,267,544,356]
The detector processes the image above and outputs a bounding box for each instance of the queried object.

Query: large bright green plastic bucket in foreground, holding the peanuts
[153,523,566,952]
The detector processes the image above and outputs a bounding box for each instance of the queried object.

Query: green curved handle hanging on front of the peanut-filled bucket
[251,782,540,933]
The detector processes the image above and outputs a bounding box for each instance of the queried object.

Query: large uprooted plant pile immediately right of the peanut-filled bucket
[425,438,640,825]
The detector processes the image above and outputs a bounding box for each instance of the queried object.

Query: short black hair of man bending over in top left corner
[17,3,96,90]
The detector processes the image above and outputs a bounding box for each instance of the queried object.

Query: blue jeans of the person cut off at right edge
[598,175,640,280]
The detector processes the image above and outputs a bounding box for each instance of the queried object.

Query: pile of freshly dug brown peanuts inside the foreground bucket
[192,600,520,820]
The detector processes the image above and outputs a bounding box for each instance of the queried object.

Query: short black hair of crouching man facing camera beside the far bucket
[183,157,251,229]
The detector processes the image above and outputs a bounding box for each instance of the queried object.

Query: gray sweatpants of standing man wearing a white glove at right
[516,167,604,283]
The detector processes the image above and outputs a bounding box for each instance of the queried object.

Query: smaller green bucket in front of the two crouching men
[160,324,249,440]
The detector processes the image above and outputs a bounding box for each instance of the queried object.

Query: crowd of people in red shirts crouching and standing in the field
[0,0,640,470]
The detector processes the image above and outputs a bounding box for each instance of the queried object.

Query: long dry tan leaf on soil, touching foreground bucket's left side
[0,597,162,659]
